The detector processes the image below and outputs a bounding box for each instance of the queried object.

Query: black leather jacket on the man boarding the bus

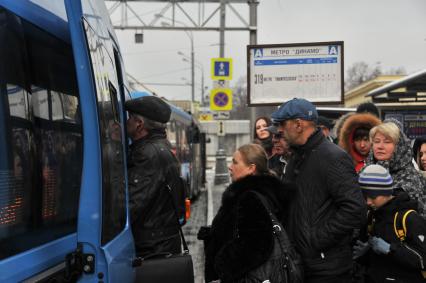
[128,131,181,255]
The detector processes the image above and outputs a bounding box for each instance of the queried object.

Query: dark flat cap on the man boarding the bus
[125,96,172,123]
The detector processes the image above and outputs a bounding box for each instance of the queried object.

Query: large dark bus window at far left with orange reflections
[0,8,82,259]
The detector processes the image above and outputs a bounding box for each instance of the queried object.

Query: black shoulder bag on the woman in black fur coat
[237,192,303,283]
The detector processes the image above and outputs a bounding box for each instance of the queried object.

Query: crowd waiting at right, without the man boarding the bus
[198,98,426,283]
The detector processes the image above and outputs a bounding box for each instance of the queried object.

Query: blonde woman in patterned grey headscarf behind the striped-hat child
[367,120,426,216]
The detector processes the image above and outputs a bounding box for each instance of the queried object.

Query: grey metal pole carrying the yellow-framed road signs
[214,0,229,185]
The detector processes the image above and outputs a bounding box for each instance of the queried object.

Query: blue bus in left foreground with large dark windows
[0,0,205,282]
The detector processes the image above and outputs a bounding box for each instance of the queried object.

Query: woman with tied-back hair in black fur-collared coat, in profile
[198,144,288,283]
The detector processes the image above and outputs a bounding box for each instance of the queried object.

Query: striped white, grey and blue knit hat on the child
[358,164,393,197]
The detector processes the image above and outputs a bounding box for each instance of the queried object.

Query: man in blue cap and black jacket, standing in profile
[271,98,366,283]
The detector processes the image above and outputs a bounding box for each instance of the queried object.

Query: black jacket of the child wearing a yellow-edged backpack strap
[367,192,426,283]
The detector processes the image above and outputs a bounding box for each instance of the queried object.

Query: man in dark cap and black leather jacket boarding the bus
[125,96,181,257]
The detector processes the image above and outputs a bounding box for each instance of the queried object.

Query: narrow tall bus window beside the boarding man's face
[84,22,126,245]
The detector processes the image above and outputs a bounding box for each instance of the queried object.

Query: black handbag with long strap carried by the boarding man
[133,185,194,283]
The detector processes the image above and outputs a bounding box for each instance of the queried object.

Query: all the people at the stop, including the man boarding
[126,97,426,283]
